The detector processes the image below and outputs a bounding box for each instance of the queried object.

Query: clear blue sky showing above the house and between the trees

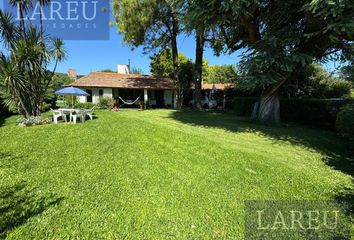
[0,0,336,74]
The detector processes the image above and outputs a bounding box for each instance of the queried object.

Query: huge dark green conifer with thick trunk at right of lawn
[190,0,354,122]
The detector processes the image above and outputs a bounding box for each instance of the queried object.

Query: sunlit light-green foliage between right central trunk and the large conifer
[203,65,239,83]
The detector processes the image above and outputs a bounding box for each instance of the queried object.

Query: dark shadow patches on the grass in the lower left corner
[0,152,63,239]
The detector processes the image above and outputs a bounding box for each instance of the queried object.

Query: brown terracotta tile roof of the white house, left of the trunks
[70,72,175,89]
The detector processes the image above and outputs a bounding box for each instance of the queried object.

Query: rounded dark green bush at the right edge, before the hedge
[336,104,354,140]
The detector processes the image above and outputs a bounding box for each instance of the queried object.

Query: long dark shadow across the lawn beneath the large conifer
[169,110,354,177]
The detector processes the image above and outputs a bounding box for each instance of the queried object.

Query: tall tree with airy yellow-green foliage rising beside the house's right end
[112,0,181,105]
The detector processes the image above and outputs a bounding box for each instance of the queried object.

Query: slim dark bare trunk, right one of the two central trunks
[193,30,205,109]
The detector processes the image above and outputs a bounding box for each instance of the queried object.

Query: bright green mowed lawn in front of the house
[0,110,354,239]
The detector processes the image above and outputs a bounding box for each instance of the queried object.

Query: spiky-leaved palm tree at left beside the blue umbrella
[0,10,66,117]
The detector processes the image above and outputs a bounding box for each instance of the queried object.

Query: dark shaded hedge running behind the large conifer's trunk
[234,97,354,130]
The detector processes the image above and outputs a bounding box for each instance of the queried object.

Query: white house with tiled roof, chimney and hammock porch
[68,65,176,108]
